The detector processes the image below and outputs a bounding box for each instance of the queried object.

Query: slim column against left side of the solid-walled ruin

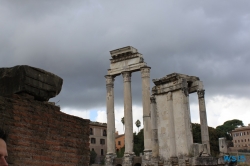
[150,96,159,158]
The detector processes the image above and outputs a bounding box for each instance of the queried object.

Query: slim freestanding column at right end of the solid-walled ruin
[197,89,210,154]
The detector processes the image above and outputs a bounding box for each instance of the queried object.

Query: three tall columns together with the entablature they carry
[105,46,151,166]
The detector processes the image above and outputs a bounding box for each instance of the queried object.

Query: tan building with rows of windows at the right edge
[232,124,250,149]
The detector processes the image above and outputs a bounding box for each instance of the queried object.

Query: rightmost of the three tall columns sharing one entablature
[141,66,152,152]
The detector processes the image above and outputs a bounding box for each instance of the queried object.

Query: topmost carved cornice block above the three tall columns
[110,46,138,59]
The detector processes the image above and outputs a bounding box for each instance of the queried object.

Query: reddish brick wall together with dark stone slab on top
[0,66,90,166]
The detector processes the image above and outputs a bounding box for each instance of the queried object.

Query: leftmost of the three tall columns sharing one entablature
[105,75,116,166]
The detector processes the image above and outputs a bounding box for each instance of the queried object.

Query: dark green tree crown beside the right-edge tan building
[216,119,244,140]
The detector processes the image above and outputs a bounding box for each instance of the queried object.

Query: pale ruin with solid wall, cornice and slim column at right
[151,73,217,165]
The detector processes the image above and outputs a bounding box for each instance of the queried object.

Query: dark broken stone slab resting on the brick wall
[0,65,63,101]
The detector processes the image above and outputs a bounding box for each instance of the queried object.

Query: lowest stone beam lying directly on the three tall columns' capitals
[108,62,147,76]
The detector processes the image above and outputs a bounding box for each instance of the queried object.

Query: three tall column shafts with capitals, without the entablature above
[105,66,152,160]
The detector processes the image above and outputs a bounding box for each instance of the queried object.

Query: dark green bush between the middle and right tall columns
[134,129,144,156]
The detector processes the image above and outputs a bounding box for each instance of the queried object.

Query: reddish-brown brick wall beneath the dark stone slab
[0,94,89,166]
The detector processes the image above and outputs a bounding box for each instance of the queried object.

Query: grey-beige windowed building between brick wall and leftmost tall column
[89,122,107,163]
